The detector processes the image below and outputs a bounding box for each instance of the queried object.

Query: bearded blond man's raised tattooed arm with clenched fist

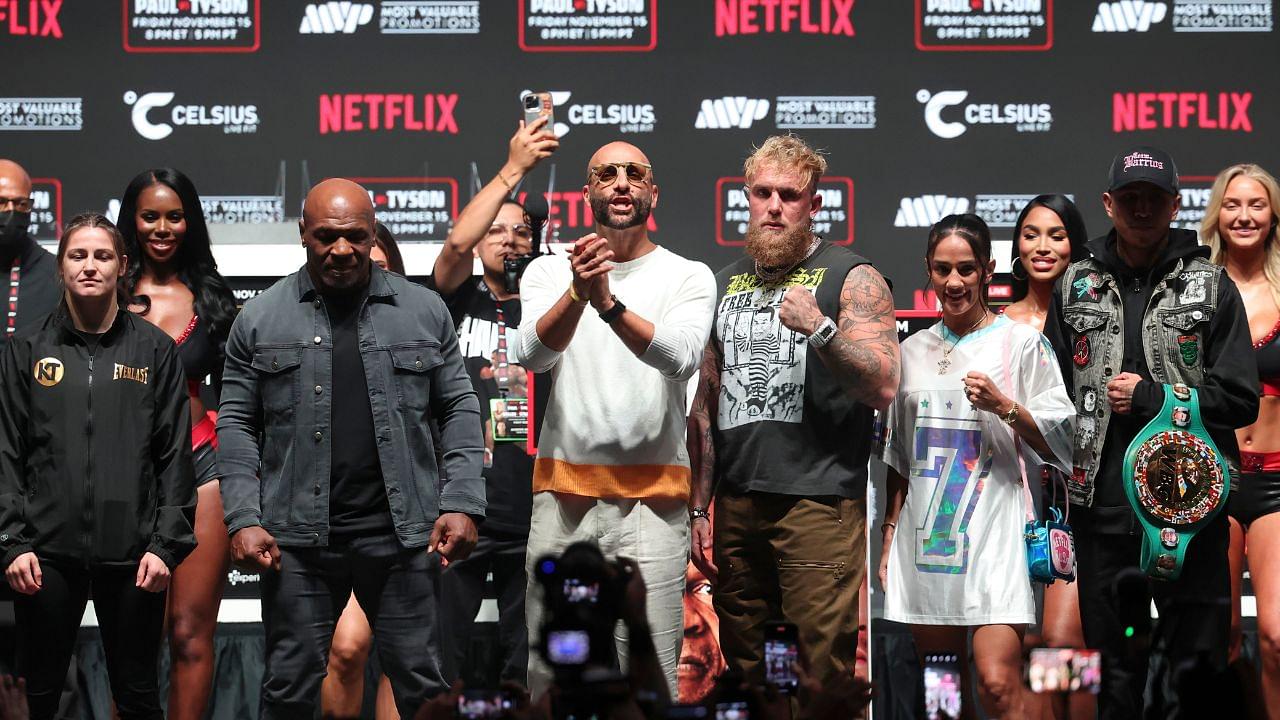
[778,265,900,410]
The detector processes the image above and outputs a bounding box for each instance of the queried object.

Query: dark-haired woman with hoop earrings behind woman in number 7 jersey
[1005,195,1097,720]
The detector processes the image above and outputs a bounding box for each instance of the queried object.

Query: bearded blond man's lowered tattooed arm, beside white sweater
[687,336,721,583]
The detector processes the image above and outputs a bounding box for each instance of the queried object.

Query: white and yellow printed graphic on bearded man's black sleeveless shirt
[716,268,827,429]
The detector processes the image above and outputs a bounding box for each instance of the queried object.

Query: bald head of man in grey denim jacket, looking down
[298,178,375,292]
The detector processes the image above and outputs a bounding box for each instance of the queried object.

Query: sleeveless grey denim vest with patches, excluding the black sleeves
[1060,258,1222,506]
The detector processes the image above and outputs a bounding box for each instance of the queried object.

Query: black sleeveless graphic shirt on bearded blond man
[712,241,874,498]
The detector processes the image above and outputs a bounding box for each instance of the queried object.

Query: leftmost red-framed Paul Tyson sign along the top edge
[120,0,262,53]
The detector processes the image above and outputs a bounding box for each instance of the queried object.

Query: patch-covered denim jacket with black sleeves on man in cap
[1046,229,1257,504]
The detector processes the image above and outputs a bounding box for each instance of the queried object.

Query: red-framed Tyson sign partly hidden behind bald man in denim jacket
[347,177,458,242]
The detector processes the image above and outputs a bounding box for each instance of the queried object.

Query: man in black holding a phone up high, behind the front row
[429,117,559,684]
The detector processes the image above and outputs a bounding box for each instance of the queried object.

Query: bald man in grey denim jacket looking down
[218,179,485,719]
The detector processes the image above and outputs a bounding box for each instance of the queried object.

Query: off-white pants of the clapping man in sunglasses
[525,492,689,698]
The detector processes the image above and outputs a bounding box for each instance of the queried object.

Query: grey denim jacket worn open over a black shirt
[218,266,485,548]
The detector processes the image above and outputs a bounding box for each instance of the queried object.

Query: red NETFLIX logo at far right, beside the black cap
[1111,92,1253,132]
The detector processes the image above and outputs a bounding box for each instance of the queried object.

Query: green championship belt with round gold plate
[1124,383,1230,580]
